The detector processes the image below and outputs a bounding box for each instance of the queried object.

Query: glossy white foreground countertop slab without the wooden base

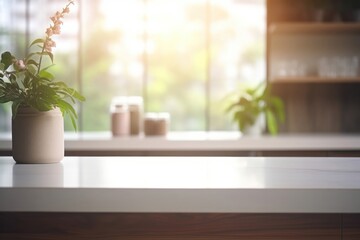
[0,157,360,213]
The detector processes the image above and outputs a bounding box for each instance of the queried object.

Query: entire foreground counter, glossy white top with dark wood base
[0,157,360,240]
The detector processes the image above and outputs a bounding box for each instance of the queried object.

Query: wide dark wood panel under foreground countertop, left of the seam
[0,213,341,240]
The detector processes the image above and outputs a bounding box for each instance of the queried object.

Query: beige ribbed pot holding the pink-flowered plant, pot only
[12,108,64,163]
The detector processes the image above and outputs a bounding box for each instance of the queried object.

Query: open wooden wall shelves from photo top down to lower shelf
[267,0,360,83]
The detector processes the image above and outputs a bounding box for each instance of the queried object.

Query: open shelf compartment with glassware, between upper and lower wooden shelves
[268,23,360,83]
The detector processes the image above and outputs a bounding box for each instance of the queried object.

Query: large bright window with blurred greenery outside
[0,0,265,131]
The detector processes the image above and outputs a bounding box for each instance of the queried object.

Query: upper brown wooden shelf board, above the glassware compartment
[268,22,360,34]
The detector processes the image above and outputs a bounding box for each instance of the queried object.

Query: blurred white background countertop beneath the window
[0,132,360,152]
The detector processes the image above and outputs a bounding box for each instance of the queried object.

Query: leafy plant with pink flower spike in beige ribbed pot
[0,0,85,163]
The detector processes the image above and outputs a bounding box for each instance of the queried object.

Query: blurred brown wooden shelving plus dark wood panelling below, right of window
[267,0,360,133]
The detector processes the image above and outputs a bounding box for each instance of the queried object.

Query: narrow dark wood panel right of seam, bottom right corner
[342,214,360,240]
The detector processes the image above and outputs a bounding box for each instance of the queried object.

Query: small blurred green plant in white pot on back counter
[226,83,285,135]
